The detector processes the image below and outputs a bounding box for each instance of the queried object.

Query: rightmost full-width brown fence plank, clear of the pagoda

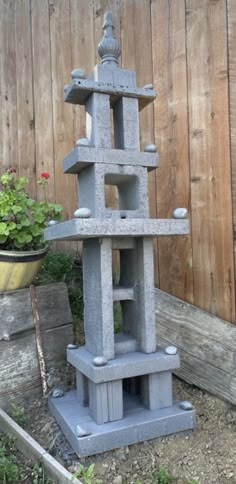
[186,0,235,322]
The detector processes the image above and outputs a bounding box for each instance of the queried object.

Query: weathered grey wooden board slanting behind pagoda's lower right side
[155,289,236,404]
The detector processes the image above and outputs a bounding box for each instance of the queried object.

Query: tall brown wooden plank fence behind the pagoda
[0,0,236,322]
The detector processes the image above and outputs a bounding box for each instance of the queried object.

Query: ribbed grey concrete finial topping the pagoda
[98,11,121,64]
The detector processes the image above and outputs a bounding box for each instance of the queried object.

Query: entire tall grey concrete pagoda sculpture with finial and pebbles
[45,12,195,456]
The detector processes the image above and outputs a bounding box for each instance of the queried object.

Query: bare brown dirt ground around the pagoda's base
[23,379,236,484]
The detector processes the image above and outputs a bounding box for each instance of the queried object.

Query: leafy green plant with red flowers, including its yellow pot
[0,168,62,291]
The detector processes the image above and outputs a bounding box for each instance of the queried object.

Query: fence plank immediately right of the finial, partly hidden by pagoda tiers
[121,0,158,284]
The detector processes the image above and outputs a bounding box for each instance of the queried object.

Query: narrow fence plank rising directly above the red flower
[31,0,55,202]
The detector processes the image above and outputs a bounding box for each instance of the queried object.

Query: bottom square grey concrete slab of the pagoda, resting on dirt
[49,390,195,456]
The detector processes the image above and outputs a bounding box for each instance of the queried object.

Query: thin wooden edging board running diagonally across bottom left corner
[0,408,82,484]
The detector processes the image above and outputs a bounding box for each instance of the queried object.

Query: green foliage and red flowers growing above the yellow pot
[0,168,62,251]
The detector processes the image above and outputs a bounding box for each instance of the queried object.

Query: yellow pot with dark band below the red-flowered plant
[0,248,48,292]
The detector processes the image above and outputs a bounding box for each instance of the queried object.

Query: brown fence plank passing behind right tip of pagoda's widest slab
[152,0,193,302]
